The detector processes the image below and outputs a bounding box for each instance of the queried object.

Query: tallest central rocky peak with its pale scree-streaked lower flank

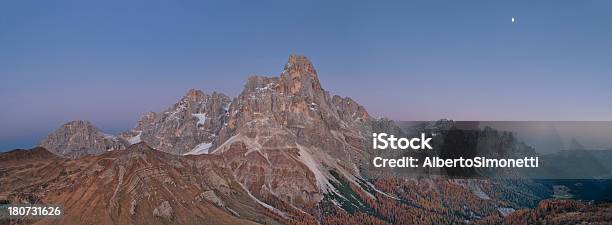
[213,56,370,207]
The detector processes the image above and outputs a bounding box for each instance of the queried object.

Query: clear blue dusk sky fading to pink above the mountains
[0,0,612,150]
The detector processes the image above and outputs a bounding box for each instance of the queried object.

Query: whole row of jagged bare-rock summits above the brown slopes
[41,55,369,162]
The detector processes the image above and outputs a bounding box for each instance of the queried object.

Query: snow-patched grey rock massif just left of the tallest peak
[120,89,230,155]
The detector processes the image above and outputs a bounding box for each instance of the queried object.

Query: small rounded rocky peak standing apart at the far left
[40,120,128,158]
